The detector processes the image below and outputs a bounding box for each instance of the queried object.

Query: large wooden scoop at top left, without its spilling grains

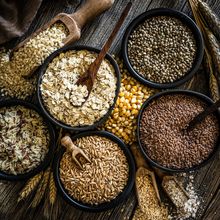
[12,0,114,56]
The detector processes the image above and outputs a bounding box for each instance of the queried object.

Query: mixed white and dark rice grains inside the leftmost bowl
[0,106,50,175]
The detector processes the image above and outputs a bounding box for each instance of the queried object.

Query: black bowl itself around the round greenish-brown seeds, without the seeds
[122,8,204,89]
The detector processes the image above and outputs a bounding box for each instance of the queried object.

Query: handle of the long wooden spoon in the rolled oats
[90,2,132,74]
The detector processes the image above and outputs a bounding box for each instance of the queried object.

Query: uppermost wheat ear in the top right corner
[198,0,220,41]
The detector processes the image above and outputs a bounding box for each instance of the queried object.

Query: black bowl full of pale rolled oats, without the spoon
[37,46,121,131]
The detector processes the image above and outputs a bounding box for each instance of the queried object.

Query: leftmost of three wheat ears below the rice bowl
[18,172,43,202]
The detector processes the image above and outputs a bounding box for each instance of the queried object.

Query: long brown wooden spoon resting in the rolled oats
[76,2,132,107]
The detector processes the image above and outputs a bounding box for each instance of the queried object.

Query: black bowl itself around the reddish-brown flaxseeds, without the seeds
[137,90,220,172]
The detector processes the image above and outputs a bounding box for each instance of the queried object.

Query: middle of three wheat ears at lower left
[31,168,50,208]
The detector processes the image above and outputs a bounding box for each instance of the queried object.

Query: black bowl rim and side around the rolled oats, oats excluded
[37,46,121,131]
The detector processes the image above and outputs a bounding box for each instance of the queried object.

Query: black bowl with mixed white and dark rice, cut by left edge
[0,99,55,181]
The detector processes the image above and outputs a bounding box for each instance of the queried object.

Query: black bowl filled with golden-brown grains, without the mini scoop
[54,131,135,212]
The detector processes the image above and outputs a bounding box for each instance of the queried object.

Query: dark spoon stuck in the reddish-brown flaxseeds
[187,99,220,131]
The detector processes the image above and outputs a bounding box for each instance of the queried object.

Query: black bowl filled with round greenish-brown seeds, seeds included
[122,8,204,89]
